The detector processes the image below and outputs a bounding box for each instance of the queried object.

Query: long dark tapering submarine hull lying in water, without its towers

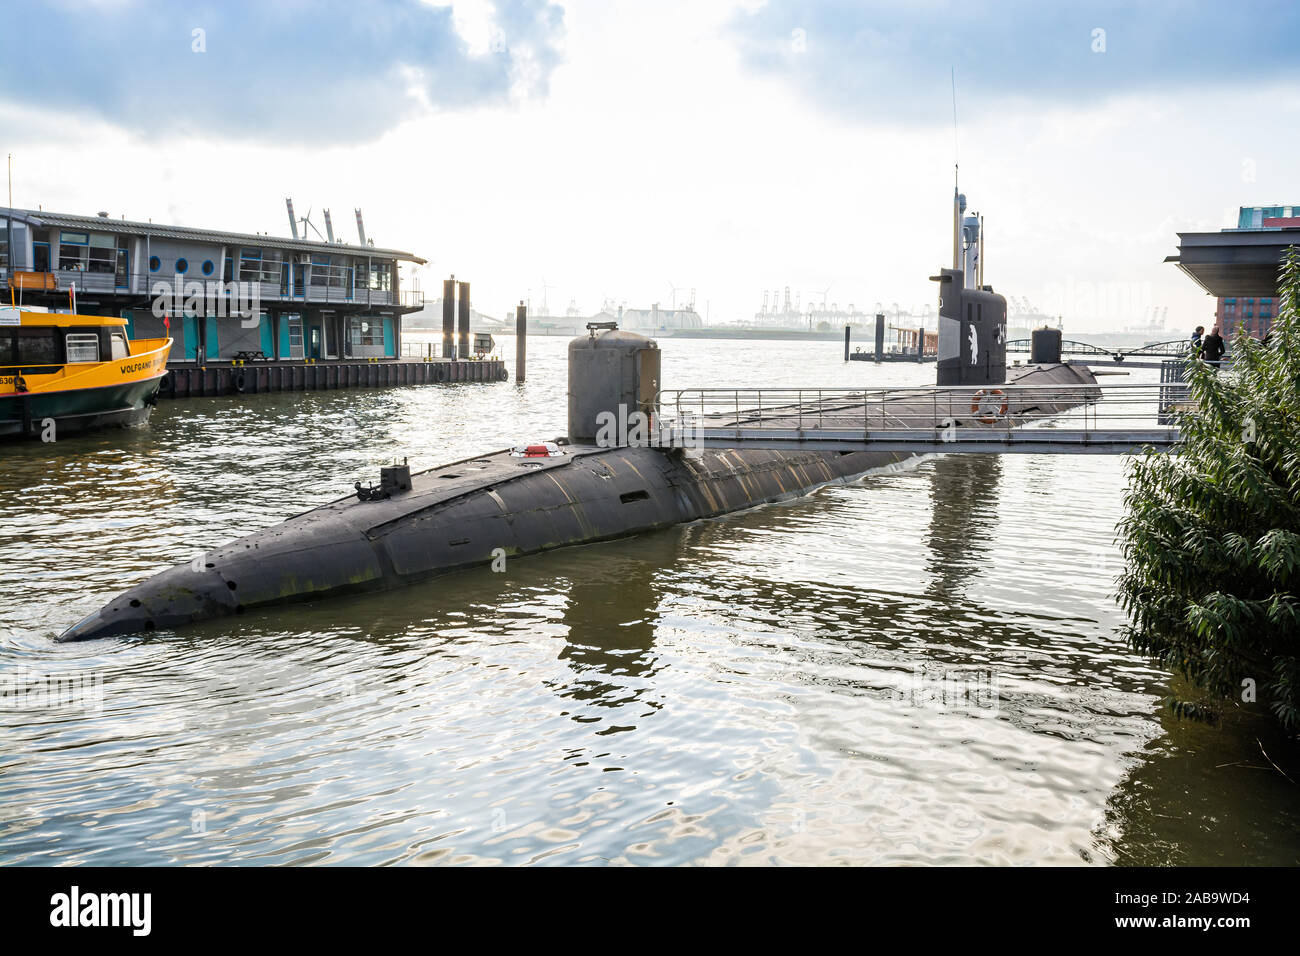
[59,365,1096,641]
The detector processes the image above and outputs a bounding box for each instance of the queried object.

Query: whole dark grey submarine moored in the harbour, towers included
[57,194,1096,641]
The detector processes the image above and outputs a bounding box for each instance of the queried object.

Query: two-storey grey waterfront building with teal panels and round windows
[0,208,425,367]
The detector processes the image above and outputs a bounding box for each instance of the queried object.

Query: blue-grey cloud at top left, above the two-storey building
[0,0,564,141]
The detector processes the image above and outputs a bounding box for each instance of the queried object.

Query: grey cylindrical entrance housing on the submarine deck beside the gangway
[568,323,660,445]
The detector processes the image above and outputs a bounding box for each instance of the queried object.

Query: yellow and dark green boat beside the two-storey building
[0,306,172,441]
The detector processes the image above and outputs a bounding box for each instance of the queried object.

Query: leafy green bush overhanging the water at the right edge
[1117,246,1300,732]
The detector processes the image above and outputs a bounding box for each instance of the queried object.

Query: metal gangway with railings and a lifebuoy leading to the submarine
[655,382,1188,454]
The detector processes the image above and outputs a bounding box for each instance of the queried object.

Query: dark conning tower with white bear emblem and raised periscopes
[931,189,1006,385]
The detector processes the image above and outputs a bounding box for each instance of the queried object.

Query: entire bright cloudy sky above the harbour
[0,0,1300,330]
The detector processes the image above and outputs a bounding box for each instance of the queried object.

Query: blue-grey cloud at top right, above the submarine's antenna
[731,0,1300,125]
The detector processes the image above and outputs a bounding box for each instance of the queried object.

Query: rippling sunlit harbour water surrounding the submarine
[0,338,1300,864]
